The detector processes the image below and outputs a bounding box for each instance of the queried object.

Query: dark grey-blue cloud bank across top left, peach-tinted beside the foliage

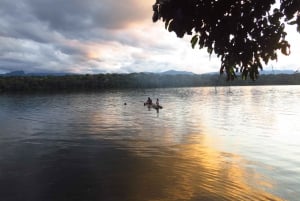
[0,0,151,42]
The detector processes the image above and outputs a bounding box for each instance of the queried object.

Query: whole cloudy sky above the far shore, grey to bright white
[0,0,300,74]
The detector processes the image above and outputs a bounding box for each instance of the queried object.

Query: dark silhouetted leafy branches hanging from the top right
[153,0,300,80]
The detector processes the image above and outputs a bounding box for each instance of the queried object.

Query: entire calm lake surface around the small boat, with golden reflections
[0,86,300,201]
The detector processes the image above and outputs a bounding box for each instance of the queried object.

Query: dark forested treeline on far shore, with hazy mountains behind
[0,73,300,93]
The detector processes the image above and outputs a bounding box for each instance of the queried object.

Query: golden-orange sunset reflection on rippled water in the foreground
[108,130,282,200]
